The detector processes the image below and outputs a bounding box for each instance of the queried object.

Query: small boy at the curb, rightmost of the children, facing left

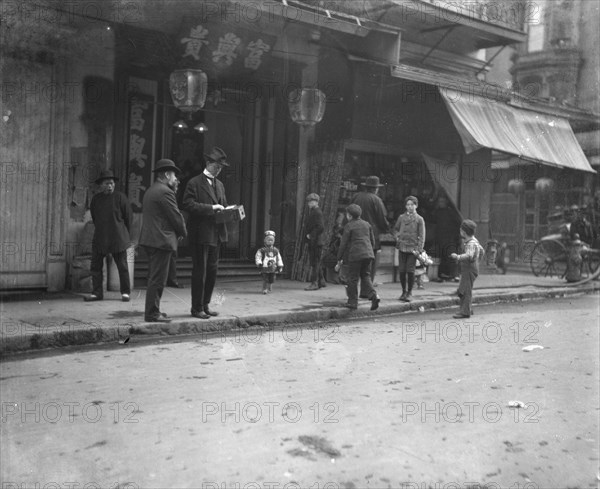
[450,219,484,319]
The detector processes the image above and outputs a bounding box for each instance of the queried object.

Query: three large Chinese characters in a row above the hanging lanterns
[179,20,275,73]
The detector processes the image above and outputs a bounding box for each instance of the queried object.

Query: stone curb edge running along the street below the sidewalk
[0,283,600,355]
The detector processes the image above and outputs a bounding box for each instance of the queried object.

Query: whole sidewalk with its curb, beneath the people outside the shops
[0,270,600,354]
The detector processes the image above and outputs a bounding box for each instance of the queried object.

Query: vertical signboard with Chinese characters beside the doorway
[128,93,154,212]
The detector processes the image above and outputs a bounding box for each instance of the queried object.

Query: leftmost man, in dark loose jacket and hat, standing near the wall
[84,170,131,302]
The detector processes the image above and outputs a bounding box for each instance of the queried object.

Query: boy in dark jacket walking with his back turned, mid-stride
[336,204,379,311]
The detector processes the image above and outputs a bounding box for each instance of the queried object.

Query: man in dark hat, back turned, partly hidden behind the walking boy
[352,176,389,298]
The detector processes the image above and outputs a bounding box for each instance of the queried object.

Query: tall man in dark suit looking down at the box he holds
[183,146,229,319]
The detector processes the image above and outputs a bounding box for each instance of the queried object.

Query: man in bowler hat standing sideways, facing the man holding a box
[140,159,187,323]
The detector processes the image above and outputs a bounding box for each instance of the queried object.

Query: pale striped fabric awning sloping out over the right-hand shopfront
[440,90,596,173]
